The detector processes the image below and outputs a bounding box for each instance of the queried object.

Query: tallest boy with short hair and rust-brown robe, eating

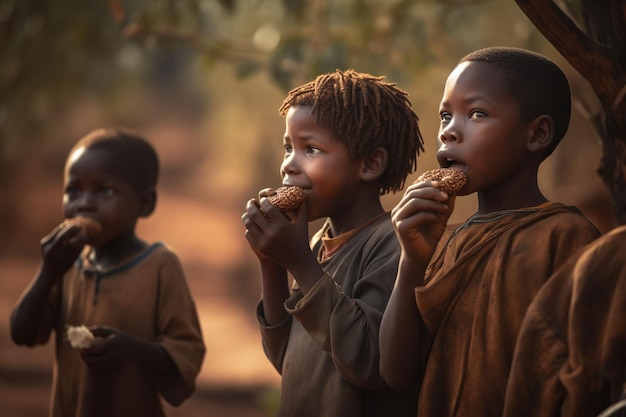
[380,47,598,417]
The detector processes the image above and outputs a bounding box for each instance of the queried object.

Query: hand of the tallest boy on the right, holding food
[391,181,455,262]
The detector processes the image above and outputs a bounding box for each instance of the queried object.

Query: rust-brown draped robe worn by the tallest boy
[415,203,599,417]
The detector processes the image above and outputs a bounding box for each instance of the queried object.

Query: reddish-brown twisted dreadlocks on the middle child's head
[279,69,424,195]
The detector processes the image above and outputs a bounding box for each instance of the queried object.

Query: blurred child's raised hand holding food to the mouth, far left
[41,223,87,282]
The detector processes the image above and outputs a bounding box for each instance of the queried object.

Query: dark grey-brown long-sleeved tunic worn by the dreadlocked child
[257,214,416,417]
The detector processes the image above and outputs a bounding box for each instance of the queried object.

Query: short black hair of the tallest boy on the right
[459,46,572,158]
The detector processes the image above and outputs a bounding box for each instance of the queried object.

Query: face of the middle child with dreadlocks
[280,106,363,220]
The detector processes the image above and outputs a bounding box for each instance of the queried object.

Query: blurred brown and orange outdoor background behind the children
[0,0,614,417]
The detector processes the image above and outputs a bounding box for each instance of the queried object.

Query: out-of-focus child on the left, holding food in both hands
[11,129,204,417]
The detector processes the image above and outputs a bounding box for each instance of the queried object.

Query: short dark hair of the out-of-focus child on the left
[70,128,159,192]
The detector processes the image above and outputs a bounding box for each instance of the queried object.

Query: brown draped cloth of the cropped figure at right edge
[503,226,626,417]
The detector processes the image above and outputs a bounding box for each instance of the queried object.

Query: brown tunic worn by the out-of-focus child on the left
[31,244,205,417]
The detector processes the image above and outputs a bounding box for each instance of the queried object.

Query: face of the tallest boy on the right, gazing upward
[437,62,531,194]
